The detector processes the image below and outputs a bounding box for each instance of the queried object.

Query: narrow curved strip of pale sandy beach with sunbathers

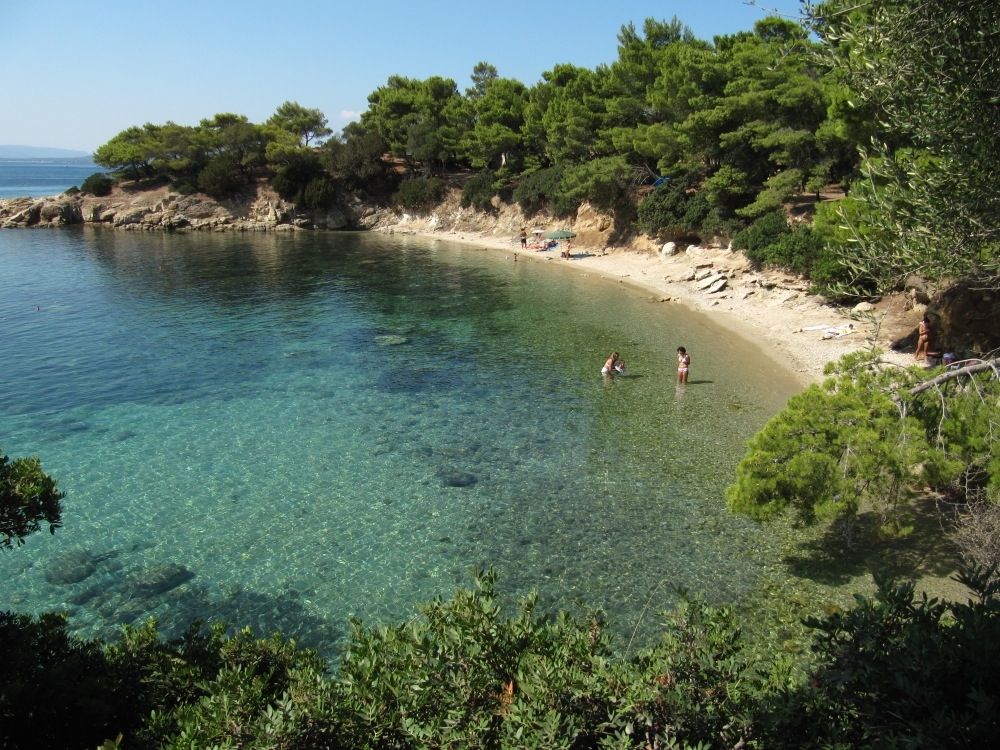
[379,224,920,386]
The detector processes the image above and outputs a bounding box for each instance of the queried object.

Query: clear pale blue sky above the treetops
[0,0,800,151]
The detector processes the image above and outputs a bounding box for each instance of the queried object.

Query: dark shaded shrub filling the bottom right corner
[785,570,1000,748]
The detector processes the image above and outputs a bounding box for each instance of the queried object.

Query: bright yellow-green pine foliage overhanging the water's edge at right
[728,351,1000,548]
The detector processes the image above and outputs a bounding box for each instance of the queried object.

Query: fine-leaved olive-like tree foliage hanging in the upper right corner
[812,0,1000,291]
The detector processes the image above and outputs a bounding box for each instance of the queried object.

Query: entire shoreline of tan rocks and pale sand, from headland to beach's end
[0,181,952,384]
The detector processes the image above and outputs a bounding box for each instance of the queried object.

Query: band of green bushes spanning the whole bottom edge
[0,571,1000,750]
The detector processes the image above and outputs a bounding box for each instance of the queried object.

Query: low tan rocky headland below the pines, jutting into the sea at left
[0,183,352,232]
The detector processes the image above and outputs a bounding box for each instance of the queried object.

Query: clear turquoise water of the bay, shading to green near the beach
[0,228,795,654]
